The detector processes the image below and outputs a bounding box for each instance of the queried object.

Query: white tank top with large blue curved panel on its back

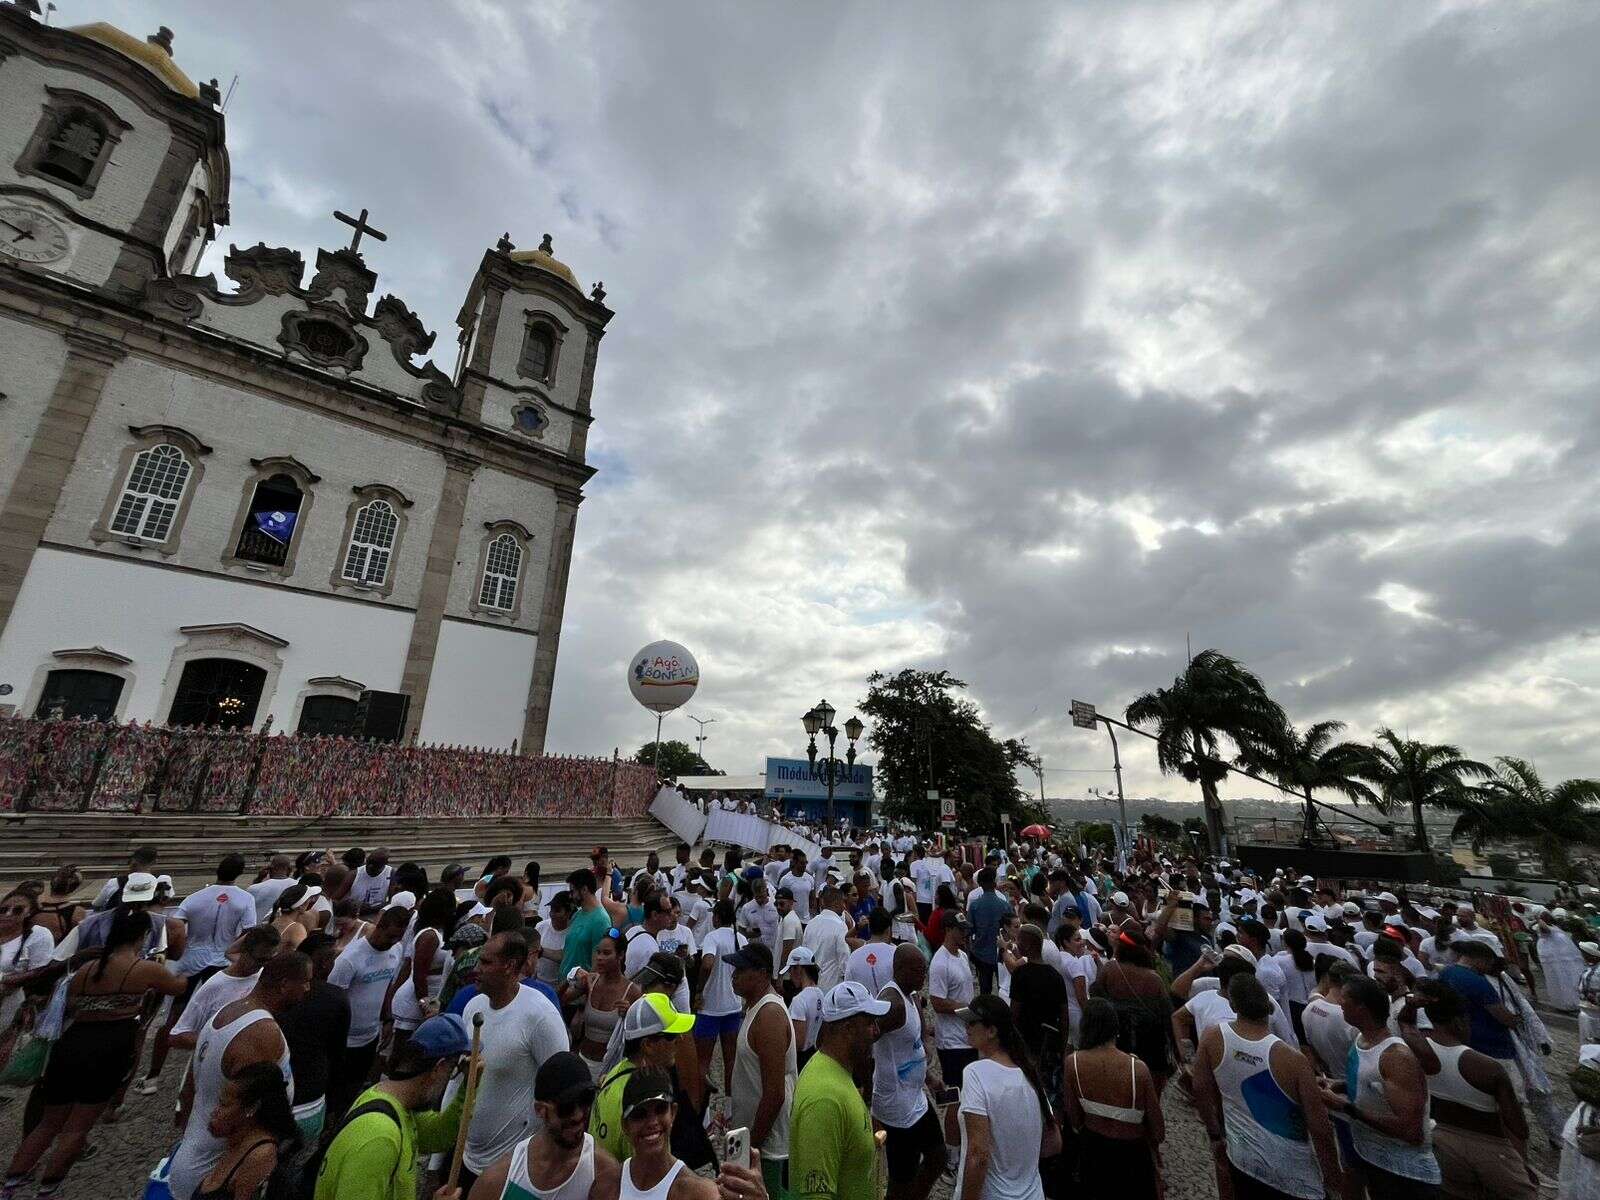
[1216,1022,1325,1200]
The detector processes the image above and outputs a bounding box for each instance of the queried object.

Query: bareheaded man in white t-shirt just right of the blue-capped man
[461,933,568,1194]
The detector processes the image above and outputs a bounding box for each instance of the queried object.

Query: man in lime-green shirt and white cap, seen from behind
[790,982,890,1200]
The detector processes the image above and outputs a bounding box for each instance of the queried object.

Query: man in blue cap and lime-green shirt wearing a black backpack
[315,1014,470,1200]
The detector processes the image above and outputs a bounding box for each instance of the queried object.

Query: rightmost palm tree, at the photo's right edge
[1453,757,1600,878]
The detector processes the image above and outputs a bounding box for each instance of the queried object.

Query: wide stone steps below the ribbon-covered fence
[0,813,677,894]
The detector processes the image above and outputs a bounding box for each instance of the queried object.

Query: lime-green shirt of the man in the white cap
[789,1051,877,1200]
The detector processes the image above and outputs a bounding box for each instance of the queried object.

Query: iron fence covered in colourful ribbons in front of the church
[0,717,656,818]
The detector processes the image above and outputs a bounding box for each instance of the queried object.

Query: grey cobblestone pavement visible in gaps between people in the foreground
[0,1018,1578,1200]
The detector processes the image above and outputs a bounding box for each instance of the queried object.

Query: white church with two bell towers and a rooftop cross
[0,0,611,754]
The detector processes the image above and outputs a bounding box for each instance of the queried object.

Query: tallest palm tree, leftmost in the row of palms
[1126,650,1285,854]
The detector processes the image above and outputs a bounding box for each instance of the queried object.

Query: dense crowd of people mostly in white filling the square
[0,832,1600,1200]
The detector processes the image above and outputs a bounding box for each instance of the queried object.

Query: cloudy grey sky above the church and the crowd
[96,0,1600,809]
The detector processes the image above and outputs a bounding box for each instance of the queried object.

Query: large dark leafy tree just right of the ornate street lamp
[856,669,1035,834]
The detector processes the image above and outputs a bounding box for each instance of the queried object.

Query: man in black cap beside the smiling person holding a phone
[469,1050,621,1200]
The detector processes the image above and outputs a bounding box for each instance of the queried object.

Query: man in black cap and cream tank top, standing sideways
[723,947,796,1197]
